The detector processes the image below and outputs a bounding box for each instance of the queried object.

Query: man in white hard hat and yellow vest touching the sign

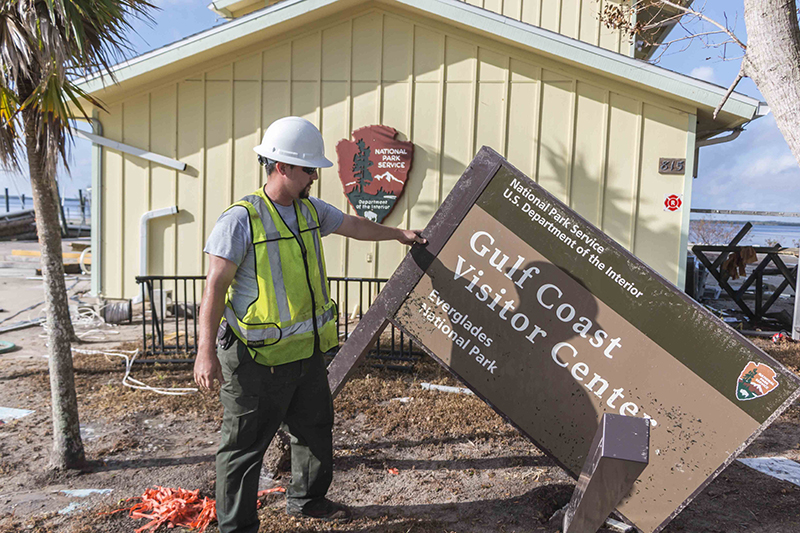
[194,117,425,533]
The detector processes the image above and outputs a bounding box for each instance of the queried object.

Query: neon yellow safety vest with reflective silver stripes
[224,189,339,366]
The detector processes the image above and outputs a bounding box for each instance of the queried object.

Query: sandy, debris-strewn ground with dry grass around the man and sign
[0,243,800,533]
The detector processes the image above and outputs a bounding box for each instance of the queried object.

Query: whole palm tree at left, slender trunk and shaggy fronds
[0,0,154,468]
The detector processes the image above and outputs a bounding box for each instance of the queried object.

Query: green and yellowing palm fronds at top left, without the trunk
[0,0,157,170]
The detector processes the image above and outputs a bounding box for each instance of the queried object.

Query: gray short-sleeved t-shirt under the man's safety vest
[203,198,344,316]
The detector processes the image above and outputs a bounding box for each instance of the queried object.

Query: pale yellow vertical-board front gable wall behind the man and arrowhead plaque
[97,4,688,298]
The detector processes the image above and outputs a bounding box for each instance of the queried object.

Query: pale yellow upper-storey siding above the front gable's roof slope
[462,0,631,55]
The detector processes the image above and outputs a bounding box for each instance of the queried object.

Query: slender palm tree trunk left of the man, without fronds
[23,109,86,469]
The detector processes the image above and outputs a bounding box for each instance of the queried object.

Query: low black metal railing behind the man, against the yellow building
[136,276,423,370]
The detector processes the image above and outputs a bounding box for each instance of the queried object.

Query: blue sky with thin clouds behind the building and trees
[0,0,800,215]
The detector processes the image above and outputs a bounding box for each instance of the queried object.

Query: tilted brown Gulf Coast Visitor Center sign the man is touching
[329,147,800,532]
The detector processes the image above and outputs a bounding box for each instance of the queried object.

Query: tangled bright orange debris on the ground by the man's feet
[104,487,286,533]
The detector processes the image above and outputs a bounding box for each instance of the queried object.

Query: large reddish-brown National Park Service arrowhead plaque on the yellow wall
[336,125,414,224]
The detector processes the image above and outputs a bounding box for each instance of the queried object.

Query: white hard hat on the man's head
[253,117,333,168]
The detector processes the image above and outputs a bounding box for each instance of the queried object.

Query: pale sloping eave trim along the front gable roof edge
[81,0,759,125]
